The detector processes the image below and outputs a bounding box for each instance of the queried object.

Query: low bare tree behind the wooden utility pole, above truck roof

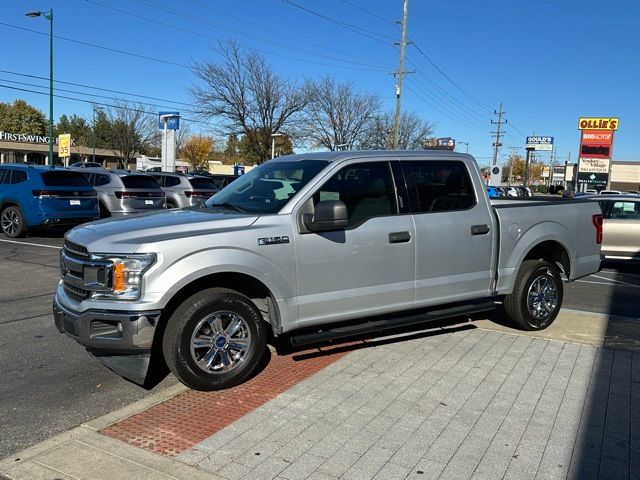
[364,111,433,150]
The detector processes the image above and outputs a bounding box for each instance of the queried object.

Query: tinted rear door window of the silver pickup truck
[402,160,476,213]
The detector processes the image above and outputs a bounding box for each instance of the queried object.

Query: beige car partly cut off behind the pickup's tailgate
[583,194,640,260]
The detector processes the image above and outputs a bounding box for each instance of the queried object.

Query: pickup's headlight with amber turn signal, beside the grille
[91,253,156,300]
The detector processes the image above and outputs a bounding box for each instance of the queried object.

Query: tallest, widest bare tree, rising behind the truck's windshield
[191,42,307,162]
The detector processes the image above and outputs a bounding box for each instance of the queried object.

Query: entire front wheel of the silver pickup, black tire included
[162,288,267,391]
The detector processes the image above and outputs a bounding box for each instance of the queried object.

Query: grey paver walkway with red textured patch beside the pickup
[101,326,640,480]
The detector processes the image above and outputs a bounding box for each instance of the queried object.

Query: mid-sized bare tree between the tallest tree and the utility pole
[305,76,381,150]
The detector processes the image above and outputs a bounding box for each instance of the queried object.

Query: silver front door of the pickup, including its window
[295,161,415,326]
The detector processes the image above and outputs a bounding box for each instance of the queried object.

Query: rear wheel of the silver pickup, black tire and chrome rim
[503,260,564,330]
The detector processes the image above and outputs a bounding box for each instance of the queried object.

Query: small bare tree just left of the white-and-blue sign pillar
[107,99,160,168]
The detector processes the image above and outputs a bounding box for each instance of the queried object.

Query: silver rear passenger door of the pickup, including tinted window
[402,160,494,307]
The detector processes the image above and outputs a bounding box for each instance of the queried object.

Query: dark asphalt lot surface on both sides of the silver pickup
[0,235,640,458]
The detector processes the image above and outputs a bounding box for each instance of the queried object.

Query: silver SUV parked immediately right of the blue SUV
[70,168,166,218]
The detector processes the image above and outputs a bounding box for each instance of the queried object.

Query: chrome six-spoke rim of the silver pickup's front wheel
[191,311,251,373]
